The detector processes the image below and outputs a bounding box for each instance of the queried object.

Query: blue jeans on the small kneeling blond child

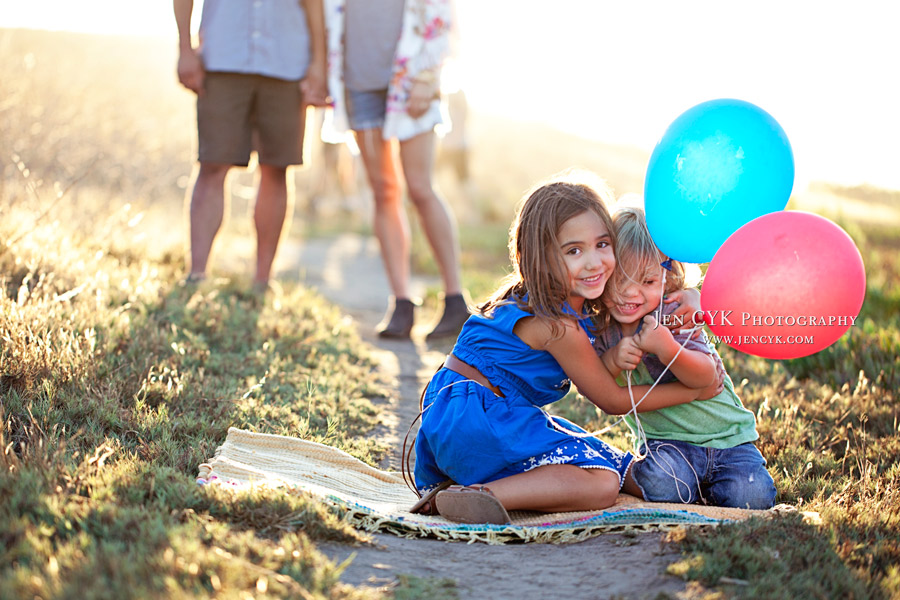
[632,440,775,509]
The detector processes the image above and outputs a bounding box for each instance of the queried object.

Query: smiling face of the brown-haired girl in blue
[559,211,616,310]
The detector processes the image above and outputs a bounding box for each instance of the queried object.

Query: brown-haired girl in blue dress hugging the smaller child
[411,171,719,523]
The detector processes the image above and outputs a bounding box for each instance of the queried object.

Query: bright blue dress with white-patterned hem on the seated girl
[415,303,633,493]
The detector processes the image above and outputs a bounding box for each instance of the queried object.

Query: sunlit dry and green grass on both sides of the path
[0,31,900,598]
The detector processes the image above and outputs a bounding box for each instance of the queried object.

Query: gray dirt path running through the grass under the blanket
[280,234,690,600]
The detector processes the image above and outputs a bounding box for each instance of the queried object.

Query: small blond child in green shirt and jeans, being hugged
[595,208,775,509]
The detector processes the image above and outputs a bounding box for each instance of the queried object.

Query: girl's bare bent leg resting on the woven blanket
[485,465,619,512]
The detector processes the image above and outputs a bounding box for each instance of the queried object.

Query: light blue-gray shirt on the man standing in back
[200,0,309,80]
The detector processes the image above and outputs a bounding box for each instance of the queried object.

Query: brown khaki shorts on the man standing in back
[197,72,306,167]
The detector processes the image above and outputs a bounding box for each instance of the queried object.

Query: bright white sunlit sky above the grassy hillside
[7,0,900,189]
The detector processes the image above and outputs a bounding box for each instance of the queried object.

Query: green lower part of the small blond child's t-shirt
[616,362,759,450]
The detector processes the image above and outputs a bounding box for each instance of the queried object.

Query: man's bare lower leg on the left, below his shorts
[188,162,230,279]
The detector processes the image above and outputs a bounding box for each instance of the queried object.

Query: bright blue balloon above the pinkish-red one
[644,99,794,263]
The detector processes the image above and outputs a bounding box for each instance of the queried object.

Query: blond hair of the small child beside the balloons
[603,206,685,308]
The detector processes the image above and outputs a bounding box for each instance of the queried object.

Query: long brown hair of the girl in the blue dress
[480,172,615,332]
